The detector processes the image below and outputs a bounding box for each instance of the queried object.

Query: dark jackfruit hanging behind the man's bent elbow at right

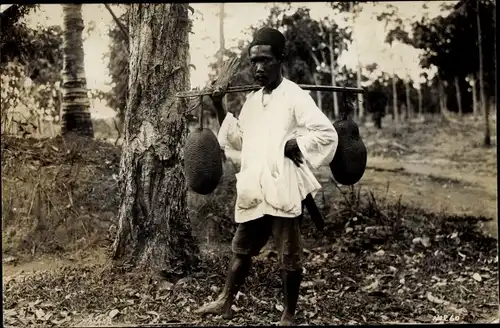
[330,119,368,186]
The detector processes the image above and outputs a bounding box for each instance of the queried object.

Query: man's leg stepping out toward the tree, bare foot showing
[196,217,272,319]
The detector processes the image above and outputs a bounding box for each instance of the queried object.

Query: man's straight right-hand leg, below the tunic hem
[273,216,302,326]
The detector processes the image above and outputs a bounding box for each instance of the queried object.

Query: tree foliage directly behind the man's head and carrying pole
[210,6,356,113]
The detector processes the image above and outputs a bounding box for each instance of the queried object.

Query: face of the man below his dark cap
[250,45,281,87]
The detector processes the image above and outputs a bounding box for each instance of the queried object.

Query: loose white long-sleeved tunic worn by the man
[218,78,338,223]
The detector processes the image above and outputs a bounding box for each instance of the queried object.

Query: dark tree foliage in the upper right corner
[388,0,495,109]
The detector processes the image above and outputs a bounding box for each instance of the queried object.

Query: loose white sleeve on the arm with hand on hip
[294,90,338,169]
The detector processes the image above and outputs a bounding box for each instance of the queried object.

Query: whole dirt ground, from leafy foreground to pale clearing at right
[2,115,499,326]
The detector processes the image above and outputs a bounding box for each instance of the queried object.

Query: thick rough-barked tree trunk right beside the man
[113,3,199,276]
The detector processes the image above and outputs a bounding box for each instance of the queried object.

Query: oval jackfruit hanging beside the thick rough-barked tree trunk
[184,128,222,195]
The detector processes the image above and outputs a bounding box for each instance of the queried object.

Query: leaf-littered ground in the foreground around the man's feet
[3,202,498,326]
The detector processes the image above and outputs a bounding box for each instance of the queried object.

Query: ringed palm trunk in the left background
[61,4,94,137]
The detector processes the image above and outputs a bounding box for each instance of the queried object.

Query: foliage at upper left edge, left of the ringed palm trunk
[0,5,63,123]
